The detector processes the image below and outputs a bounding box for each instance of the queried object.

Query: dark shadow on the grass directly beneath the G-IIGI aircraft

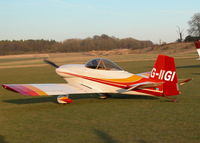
[4,94,158,104]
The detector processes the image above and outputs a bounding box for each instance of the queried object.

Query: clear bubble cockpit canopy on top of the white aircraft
[85,58,123,70]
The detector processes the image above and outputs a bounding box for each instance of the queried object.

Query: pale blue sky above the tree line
[0,0,200,43]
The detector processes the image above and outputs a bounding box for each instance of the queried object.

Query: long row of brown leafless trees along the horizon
[0,34,153,55]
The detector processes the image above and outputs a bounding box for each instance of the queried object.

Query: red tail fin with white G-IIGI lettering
[150,55,179,96]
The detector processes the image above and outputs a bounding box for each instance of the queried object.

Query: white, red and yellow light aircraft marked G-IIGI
[2,55,191,104]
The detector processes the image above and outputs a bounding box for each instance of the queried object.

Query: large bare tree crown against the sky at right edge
[188,13,200,37]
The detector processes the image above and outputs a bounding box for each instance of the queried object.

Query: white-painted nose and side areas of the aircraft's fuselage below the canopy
[56,64,151,95]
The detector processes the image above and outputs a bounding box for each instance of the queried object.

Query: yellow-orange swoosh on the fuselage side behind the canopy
[103,75,142,83]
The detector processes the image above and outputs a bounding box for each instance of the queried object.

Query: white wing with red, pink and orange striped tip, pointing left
[2,84,90,96]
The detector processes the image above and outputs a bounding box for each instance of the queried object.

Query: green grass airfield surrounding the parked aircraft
[0,59,200,143]
